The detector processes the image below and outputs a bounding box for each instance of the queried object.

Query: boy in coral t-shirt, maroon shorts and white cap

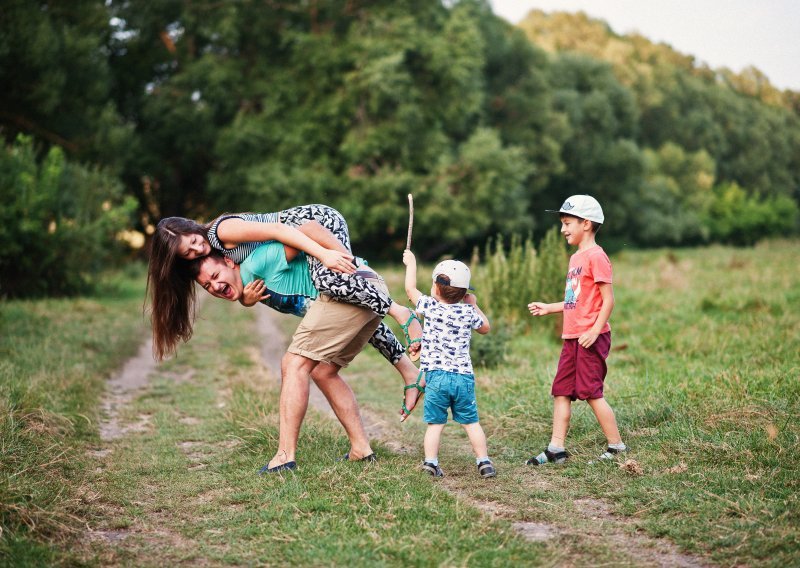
[526,195,627,465]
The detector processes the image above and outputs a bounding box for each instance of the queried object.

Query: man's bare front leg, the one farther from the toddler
[268,353,317,468]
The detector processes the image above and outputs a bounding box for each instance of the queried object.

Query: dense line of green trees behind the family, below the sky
[0,0,800,298]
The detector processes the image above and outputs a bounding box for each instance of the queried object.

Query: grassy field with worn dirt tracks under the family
[0,241,800,566]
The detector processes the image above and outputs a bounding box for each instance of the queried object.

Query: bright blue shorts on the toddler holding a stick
[424,371,478,424]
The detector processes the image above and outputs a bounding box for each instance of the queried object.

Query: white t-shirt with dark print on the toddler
[417,295,483,375]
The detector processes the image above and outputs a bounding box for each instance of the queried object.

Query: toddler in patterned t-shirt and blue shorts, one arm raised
[403,250,497,477]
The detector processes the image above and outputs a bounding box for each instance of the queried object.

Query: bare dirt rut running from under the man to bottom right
[257,309,709,568]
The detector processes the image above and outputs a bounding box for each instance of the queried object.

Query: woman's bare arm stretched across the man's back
[217,217,356,274]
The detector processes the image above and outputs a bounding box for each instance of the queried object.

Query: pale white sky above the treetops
[490,0,800,91]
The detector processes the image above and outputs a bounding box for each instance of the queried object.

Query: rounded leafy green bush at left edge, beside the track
[0,136,136,297]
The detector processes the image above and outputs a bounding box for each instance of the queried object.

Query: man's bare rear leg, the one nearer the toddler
[311,363,372,460]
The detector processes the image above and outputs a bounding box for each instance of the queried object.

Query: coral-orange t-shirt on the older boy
[561,245,611,339]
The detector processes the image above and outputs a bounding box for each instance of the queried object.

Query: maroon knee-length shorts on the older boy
[550,331,611,400]
